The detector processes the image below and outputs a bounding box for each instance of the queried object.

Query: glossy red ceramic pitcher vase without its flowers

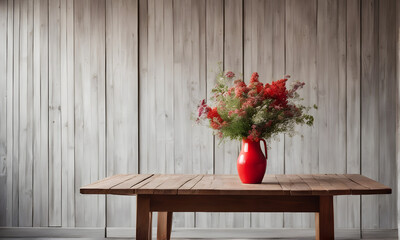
[237,138,267,184]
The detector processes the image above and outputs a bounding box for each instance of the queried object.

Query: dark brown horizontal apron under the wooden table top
[146,195,320,212]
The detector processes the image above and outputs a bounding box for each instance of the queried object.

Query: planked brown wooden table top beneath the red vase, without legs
[80,174,392,195]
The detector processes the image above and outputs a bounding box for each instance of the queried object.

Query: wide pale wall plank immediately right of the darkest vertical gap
[139,0,173,229]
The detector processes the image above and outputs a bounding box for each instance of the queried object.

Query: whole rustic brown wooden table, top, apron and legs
[81,174,392,239]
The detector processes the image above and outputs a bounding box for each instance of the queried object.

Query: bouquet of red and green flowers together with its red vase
[196,71,316,183]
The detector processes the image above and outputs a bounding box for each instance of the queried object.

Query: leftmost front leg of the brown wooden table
[136,195,152,240]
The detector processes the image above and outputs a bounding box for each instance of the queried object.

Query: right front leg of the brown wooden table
[315,196,335,240]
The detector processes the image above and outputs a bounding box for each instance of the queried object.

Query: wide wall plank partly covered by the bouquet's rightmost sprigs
[284,0,319,228]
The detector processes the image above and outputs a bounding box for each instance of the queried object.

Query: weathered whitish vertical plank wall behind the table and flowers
[0,0,400,233]
